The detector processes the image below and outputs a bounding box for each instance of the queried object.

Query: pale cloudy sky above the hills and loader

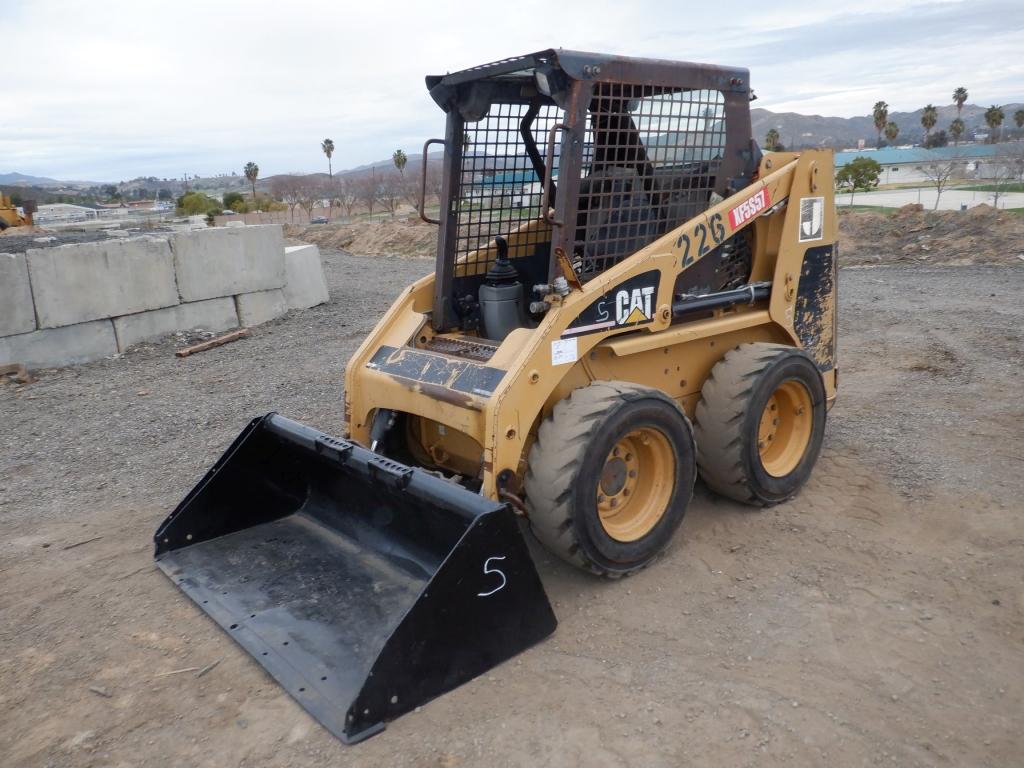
[0,0,1024,181]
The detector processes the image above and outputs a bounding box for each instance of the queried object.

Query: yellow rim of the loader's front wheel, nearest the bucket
[597,427,676,542]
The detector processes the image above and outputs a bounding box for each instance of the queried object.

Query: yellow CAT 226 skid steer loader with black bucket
[156,50,836,741]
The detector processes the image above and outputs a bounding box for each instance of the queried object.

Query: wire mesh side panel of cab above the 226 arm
[572,83,726,281]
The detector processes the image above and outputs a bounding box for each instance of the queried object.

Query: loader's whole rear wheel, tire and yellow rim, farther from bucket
[694,343,825,506]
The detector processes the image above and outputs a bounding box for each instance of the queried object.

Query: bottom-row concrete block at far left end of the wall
[0,319,118,368]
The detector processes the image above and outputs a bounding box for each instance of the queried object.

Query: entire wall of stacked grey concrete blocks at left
[0,225,329,368]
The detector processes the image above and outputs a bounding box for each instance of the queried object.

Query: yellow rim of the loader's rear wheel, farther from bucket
[758,380,813,477]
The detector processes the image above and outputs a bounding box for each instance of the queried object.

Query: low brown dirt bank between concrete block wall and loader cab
[285,216,437,258]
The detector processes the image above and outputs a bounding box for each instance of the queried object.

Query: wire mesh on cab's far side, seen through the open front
[455,103,562,274]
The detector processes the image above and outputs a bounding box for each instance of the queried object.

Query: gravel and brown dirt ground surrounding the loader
[0,243,1024,768]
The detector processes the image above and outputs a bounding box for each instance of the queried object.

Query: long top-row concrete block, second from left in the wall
[27,238,178,328]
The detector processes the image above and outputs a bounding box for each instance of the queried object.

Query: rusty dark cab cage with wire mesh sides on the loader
[427,50,757,333]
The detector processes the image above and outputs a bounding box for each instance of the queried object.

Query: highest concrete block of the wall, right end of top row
[171,224,285,301]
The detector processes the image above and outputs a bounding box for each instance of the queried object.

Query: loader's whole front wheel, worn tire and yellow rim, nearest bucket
[525,381,696,578]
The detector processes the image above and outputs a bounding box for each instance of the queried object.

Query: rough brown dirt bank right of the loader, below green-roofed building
[839,203,1024,265]
